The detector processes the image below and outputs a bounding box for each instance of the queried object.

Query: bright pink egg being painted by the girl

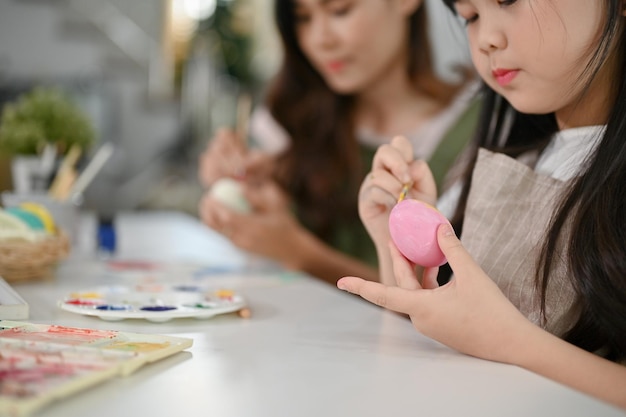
[389,199,449,267]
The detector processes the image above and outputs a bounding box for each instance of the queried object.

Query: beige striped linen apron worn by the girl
[461,149,578,336]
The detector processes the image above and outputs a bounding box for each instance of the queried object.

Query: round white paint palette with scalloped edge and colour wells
[58,283,246,322]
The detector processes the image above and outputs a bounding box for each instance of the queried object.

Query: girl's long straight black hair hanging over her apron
[444,0,626,361]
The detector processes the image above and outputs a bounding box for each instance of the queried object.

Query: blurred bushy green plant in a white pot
[0,87,95,192]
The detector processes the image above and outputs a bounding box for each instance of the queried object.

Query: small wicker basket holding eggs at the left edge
[0,232,70,282]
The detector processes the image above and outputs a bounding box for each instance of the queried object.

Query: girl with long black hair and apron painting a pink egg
[338,0,626,408]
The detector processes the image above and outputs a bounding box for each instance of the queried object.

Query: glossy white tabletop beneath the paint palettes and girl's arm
[9,213,626,417]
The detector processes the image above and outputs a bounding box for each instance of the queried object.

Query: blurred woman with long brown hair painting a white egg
[199,0,478,284]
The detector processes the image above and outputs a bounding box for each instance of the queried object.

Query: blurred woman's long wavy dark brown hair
[266,0,459,238]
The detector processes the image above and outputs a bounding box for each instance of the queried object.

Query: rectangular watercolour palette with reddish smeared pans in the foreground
[0,320,193,416]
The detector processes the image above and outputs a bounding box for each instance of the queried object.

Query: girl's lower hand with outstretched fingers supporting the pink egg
[337,225,539,363]
